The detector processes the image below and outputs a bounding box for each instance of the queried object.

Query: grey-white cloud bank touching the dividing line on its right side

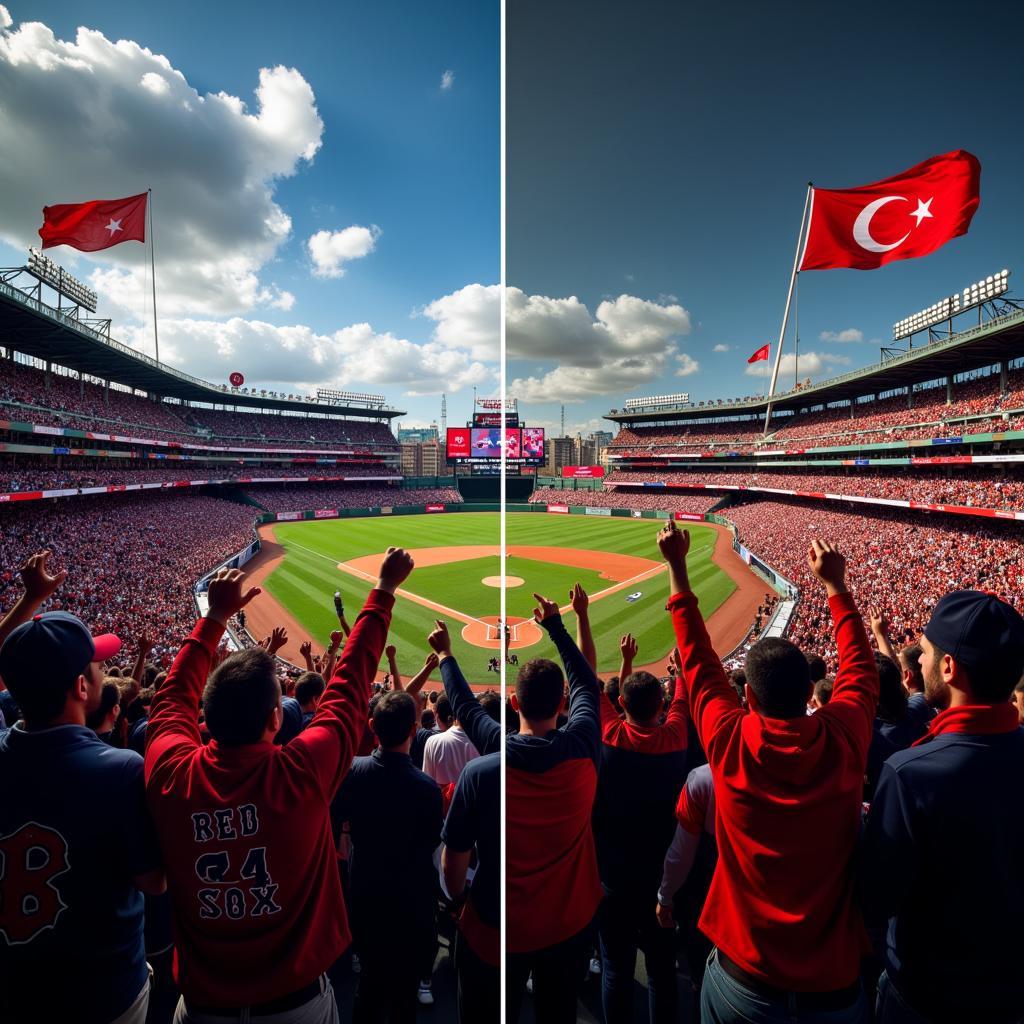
[505,288,698,402]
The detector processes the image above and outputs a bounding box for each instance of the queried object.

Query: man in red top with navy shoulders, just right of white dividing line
[505,594,601,1024]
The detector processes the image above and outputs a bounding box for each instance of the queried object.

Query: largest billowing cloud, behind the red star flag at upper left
[0,10,324,317]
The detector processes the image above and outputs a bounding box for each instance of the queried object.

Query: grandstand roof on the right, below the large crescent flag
[604,310,1024,426]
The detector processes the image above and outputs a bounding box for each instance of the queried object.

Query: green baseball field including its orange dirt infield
[256,512,736,685]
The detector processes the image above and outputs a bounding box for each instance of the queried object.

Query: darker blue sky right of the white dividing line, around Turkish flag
[507,0,1024,430]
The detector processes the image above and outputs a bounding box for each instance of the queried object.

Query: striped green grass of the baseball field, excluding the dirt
[265,512,735,684]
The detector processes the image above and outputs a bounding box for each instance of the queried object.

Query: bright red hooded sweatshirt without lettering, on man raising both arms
[669,592,879,992]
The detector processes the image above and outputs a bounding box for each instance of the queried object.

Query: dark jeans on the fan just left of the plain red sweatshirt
[598,893,679,1024]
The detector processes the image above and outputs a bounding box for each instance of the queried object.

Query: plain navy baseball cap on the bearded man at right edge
[925,590,1024,669]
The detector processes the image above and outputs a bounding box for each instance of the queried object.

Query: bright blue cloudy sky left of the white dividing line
[0,0,500,423]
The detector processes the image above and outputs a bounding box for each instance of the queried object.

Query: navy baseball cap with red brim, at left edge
[0,611,121,688]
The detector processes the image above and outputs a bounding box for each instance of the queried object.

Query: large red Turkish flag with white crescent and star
[800,150,981,270]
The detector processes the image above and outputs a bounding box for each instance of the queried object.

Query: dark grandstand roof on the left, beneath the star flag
[0,281,406,420]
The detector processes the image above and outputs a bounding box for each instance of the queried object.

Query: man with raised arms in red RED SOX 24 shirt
[145,548,413,1024]
